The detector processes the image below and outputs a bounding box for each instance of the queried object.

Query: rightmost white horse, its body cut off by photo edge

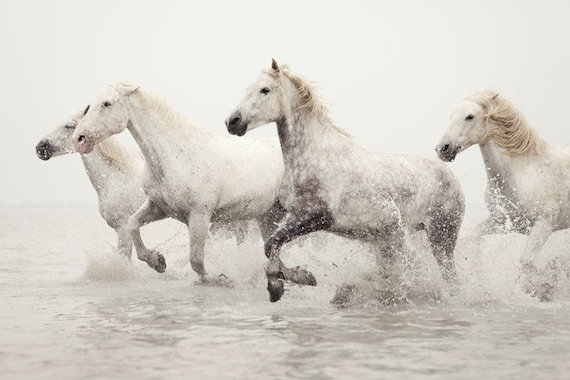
[436,91,570,298]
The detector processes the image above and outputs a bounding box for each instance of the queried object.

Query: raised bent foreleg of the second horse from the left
[127,199,166,273]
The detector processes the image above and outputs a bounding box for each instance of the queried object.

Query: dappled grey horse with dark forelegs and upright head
[226,61,464,302]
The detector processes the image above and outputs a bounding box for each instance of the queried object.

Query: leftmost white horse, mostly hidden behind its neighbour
[36,109,146,259]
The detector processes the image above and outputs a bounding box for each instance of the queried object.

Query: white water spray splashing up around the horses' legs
[76,214,570,309]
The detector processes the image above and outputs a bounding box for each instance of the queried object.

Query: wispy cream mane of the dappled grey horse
[269,65,352,137]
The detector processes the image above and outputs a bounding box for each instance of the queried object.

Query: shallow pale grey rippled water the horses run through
[0,208,570,379]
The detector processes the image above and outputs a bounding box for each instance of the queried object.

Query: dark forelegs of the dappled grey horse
[265,210,333,302]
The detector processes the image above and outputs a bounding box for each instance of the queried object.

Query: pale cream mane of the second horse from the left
[125,88,205,140]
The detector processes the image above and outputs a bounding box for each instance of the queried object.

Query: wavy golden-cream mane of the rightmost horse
[467,91,545,156]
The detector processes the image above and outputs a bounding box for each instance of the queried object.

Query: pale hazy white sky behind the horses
[0,0,570,220]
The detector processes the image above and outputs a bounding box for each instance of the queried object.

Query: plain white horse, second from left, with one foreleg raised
[73,83,284,283]
